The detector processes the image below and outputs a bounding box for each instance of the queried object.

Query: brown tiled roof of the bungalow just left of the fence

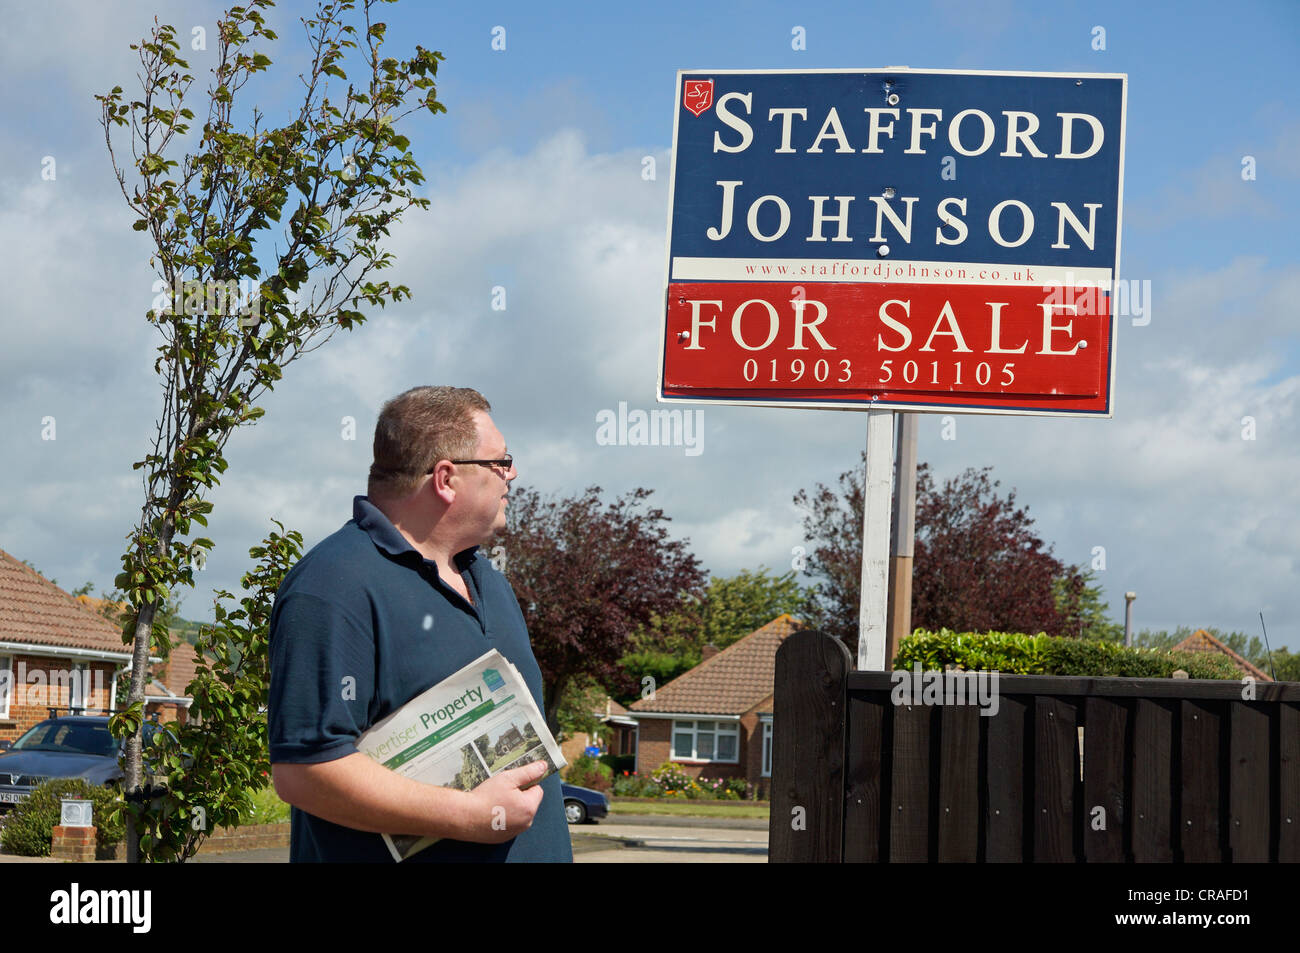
[631,615,798,715]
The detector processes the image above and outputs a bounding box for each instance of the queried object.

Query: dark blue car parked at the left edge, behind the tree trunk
[0,715,169,813]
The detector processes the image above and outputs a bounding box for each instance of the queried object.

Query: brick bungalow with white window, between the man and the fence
[628,615,798,797]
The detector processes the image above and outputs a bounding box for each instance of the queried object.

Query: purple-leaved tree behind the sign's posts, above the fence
[794,460,1078,647]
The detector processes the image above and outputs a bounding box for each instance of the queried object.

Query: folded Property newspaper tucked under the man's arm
[356,649,566,863]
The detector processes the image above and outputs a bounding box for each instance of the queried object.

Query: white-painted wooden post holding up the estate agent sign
[858,411,894,672]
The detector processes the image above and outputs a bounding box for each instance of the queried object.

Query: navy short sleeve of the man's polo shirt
[267,593,374,764]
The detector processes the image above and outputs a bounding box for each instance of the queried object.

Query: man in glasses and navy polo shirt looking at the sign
[269,387,572,863]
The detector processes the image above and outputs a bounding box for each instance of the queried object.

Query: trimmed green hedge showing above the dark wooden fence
[894,629,1242,680]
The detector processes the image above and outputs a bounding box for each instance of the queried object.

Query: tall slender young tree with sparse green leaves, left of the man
[96,0,443,861]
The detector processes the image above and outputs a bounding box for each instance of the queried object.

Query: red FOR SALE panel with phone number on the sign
[663,282,1112,413]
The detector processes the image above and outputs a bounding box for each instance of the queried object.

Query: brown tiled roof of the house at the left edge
[0,550,130,655]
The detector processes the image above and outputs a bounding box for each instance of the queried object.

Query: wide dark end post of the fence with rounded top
[767,629,852,863]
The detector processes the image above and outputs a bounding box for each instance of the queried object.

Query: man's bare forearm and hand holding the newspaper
[270,751,546,844]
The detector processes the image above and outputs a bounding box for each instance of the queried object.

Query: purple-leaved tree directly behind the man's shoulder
[498,486,705,732]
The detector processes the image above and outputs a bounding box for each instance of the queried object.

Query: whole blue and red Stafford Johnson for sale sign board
[659,69,1126,416]
